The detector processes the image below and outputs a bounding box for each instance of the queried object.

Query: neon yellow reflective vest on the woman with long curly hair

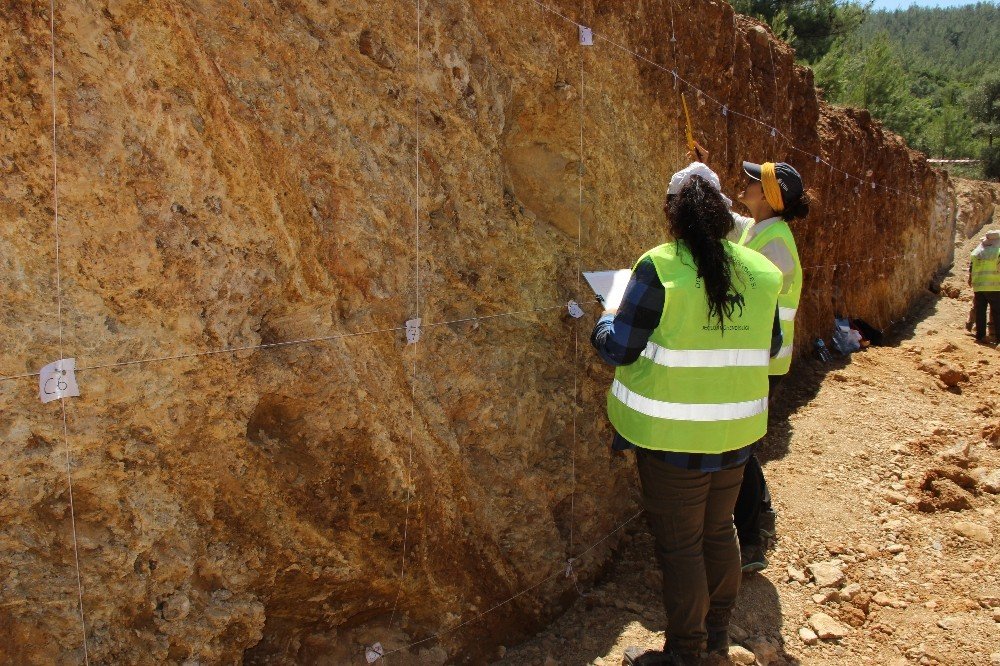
[608,241,782,454]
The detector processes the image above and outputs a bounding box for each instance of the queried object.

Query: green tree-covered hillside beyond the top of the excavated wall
[732,0,1000,179]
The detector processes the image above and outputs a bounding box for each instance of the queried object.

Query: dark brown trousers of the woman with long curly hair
[636,448,743,652]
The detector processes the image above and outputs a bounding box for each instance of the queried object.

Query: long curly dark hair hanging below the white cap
[667,176,734,331]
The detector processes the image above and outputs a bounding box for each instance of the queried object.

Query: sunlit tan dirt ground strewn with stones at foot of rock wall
[500,218,1000,666]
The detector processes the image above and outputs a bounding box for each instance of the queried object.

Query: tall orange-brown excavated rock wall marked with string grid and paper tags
[0,0,954,663]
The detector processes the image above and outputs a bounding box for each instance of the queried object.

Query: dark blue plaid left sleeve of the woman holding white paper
[590,257,664,366]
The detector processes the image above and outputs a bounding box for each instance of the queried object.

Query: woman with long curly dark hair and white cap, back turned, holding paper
[591,163,782,666]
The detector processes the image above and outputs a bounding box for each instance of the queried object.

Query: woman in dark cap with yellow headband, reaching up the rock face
[693,143,811,573]
